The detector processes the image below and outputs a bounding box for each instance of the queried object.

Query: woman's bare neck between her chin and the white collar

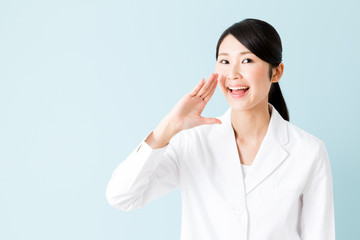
[231,103,270,143]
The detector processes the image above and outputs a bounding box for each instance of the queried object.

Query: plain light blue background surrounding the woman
[0,0,360,240]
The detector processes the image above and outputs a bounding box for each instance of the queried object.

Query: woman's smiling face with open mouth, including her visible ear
[215,34,280,111]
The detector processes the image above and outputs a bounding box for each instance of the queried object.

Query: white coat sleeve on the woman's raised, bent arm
[106,131,179,211]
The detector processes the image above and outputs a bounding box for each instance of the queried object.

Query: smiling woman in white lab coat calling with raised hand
[107,19,335,240]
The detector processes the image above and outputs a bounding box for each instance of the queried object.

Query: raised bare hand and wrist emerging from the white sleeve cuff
[145,73,221,148]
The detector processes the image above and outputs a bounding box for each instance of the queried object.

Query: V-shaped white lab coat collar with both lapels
[215,103,288,194]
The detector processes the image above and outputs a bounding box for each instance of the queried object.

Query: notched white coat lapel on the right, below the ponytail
[245,104,288,194]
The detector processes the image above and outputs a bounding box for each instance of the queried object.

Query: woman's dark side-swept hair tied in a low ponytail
[216,18,289,121]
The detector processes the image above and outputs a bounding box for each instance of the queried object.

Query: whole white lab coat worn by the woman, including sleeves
[106,104,335,240]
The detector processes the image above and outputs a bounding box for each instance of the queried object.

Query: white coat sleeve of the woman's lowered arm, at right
[301,141,335,240]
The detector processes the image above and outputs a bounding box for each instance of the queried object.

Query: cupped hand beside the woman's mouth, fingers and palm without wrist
[168,73,221,131]
